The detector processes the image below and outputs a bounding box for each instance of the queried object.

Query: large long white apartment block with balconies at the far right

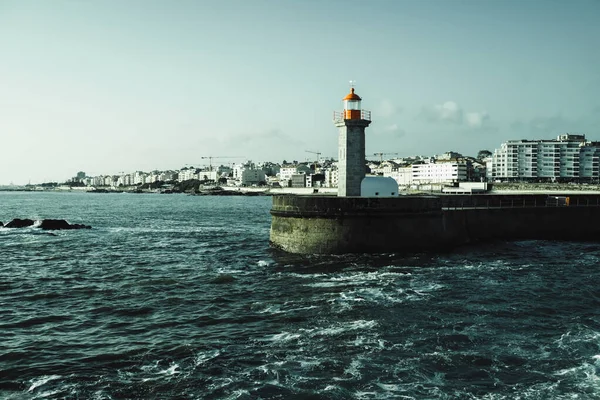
[486,134,599,181]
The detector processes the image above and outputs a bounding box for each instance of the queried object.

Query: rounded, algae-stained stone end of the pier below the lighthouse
[270,195,459,254]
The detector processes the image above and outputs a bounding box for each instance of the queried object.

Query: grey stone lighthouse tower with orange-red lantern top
[333,87,371,197]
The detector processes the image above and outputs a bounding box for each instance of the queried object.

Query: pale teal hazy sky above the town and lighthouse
[0,0,600,185]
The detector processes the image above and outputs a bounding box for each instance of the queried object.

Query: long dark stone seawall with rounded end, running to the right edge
[270,194,600,254]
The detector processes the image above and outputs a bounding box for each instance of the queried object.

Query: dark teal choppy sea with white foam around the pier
[0,192,600,400]
